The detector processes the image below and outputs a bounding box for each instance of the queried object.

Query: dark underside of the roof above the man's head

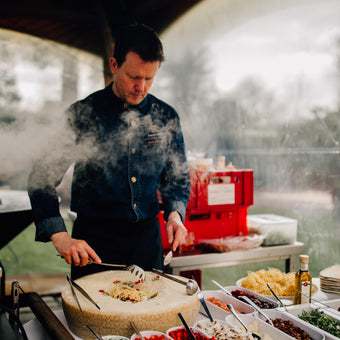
[0,0,203,55]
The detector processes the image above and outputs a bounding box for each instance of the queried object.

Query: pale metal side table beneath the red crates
[170,242,304,275]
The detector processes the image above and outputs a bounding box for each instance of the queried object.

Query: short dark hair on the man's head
[113,24,165,67]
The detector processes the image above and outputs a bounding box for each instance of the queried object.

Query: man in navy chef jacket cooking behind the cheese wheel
[28,24,190,279]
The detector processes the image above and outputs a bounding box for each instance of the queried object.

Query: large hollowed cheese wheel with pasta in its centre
[61,270,199,339]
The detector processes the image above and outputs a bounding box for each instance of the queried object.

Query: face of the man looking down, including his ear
[110,52,160,105]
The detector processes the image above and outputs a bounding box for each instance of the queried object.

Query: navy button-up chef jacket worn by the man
[28,83,190,242]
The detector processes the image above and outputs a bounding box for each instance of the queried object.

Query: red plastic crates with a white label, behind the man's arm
[158,169,254,249]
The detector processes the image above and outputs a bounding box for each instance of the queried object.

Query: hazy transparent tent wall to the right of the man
[153,0,340,288]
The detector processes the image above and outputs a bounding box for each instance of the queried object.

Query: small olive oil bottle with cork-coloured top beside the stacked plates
[294,255,312,305]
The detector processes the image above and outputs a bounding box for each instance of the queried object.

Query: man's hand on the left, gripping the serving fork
[51,231,102,266]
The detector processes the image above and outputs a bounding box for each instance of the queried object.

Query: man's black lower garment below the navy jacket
[71,216,163,279]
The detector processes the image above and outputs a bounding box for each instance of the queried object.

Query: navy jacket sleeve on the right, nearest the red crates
[160,110,190,222]
